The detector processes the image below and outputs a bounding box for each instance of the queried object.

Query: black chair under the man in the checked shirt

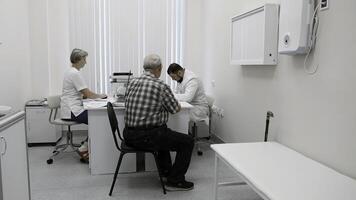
[107,102,166,196]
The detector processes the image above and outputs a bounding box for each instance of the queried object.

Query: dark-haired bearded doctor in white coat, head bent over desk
[167,63,209,122]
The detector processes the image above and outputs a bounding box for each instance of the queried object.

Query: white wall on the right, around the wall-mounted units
[185,0,356,178]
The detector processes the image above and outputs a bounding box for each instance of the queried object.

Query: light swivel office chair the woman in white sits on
[47,95,80,164]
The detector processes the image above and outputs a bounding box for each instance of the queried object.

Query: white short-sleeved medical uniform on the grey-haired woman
[61,67,88,119]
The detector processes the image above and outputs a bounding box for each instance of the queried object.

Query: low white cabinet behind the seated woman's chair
[26,106,62,146]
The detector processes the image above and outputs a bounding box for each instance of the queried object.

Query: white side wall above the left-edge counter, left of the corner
[0,0,31,110]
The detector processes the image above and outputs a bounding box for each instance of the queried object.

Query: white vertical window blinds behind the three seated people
[69,0,185,93]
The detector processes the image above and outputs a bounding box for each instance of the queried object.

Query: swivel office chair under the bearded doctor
[192,95,215,156]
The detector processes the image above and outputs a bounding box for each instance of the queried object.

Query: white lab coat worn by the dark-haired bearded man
[174,69,209,122]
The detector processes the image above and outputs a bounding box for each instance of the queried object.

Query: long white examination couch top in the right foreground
[211,142,356,200]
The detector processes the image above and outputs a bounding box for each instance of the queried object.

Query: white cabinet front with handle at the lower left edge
[0,120,30,200]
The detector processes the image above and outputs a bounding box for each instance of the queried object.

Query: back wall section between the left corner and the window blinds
[29,0,70,98]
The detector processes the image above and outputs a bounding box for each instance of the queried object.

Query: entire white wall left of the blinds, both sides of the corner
[0,0,69,109]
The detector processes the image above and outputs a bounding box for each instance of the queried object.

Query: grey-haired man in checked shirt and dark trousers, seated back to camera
[124,54,194,191]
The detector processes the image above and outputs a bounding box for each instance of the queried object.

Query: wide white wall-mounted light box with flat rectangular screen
[230,4,279,65]
